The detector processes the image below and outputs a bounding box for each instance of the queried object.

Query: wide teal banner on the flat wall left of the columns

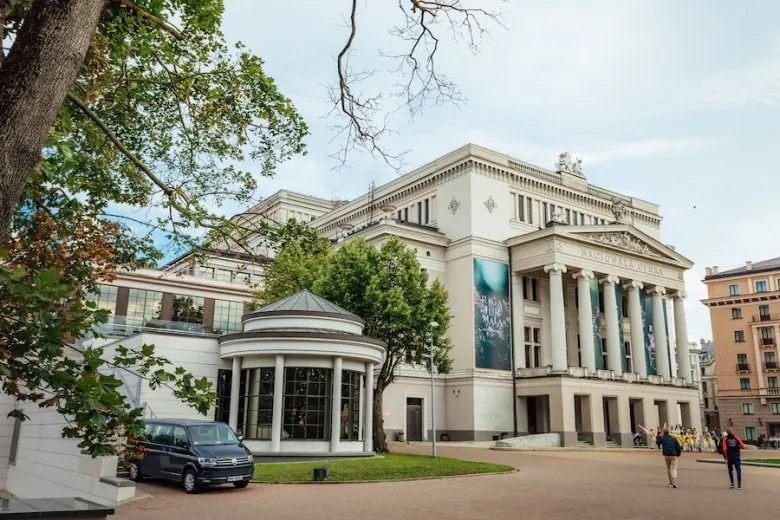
[474,258,512,370]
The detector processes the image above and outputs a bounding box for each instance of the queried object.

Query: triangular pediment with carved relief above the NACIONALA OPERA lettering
[556,224,693,267]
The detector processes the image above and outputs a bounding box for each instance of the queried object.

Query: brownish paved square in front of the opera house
[113,444,780,520]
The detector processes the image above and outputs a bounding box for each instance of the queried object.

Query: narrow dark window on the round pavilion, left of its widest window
[239,367,276,440]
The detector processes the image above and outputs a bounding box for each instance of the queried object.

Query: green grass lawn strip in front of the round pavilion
[254,453,514,483]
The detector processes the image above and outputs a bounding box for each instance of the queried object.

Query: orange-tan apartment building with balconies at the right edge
[703,257,780,441]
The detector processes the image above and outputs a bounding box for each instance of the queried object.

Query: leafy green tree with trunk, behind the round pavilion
[266,238,452,451]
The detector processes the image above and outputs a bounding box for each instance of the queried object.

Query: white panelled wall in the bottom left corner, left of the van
[5,398,135,504]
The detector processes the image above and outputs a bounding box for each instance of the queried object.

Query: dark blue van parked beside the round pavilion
[128,419,254,493]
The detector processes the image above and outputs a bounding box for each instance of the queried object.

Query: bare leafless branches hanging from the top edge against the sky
[329,0,506,170]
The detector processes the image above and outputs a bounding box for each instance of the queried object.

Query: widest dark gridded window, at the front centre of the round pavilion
[282,368,333,441]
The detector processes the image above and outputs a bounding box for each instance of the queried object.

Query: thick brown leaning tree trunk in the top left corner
[0,0,106,243]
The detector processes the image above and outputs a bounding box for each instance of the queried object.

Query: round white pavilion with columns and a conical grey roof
[219,291,384,455]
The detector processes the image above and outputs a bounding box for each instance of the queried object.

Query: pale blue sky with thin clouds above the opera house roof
[215,0,780,341]
